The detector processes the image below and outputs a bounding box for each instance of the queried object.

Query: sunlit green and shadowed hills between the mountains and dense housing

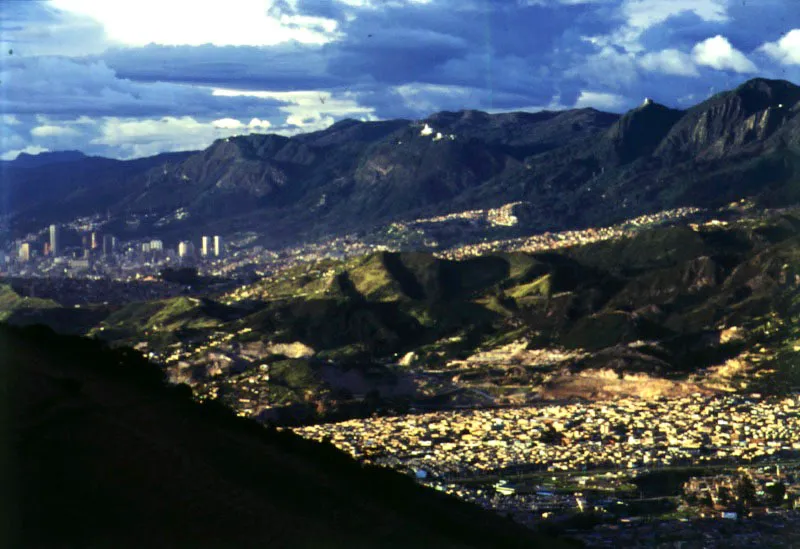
[4,208,800,414]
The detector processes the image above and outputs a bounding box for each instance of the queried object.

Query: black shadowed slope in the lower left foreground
[0,326,576,548]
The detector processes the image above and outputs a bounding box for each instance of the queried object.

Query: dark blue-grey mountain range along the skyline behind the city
[3,78,800,242]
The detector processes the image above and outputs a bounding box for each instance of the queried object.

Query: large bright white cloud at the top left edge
[51,0,338,46]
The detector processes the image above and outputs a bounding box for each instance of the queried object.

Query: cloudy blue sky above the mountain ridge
[0,0,800,160]
